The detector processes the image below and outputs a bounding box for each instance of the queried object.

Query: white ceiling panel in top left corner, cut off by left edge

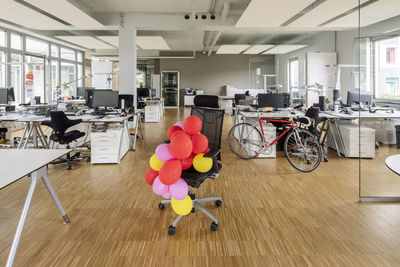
[0,0,68,30]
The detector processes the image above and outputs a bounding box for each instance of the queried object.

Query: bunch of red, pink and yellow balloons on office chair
[145,115,213,216]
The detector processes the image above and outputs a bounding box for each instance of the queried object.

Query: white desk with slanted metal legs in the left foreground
[0,149,71,267]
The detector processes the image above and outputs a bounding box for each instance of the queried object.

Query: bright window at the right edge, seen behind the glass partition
[372,37,400,100]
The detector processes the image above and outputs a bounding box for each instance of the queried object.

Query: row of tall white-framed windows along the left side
[0,28,84,103]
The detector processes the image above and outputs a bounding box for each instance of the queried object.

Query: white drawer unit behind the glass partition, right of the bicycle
[328,124,375,158]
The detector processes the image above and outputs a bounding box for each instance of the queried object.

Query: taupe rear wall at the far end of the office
[160,53,249,95]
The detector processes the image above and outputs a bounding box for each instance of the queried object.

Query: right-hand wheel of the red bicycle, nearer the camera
[284,128,322,172]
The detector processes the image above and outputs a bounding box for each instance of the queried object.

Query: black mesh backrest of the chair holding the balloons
[191,106,225,160]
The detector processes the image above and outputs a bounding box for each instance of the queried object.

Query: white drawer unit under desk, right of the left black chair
[90,127,129,163]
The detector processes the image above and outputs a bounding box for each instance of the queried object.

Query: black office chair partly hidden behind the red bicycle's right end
[305,107,329,162]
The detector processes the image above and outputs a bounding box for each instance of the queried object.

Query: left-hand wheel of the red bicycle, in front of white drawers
[228,123,264,159]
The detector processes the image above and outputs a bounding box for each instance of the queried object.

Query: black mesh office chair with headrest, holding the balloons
[158,95,225,235]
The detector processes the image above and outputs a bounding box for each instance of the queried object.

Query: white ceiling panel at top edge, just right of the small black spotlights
[235,0,315,28]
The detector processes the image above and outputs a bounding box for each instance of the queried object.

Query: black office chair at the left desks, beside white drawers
[42,111,87,170]
